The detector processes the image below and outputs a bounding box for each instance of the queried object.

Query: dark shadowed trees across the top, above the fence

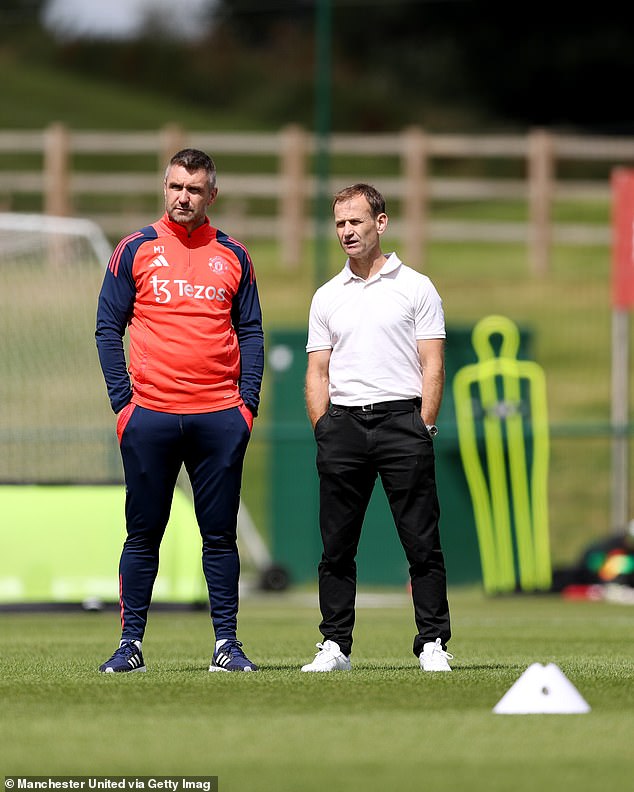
[0,0,634,134]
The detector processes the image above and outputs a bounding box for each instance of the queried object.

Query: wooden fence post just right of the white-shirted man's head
[401,127,427,270]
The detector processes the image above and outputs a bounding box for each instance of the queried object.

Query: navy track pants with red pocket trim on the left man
[117,405,250,640]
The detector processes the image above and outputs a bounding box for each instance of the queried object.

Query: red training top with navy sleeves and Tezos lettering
[96,214,264,414]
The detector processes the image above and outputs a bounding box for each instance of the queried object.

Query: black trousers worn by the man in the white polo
[315,403,451,656]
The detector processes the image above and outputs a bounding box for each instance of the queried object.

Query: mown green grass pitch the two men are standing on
[0,588,634,792]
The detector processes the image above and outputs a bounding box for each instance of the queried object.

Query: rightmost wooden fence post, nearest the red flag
[528,129,554,275]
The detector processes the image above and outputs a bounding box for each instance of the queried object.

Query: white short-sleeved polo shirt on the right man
[306,253,445,406]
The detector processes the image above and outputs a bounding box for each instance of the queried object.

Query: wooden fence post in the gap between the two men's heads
[279,124,307,268]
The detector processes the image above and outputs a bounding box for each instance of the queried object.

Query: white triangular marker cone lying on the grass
[493,663,590,715]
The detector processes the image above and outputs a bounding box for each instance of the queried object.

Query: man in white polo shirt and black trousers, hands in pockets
[302,184,452,671]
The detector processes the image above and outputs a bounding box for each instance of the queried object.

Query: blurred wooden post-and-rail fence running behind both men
[0,124,634,274]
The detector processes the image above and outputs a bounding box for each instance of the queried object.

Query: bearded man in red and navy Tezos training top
[95,149,264,673]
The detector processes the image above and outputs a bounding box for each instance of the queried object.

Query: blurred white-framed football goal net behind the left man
[0,213,116,484]
